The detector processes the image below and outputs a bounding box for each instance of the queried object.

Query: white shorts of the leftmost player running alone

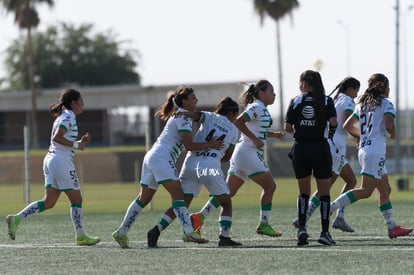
[43,153,80,191]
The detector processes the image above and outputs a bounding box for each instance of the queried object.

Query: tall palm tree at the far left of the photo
[2,0,54,148]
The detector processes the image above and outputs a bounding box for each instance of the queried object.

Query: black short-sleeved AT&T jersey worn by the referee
[286,92,336,140]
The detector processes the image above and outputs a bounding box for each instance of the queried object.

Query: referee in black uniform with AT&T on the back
[285,70,337,246]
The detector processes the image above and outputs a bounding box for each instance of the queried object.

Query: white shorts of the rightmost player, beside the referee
[358,150,387,179]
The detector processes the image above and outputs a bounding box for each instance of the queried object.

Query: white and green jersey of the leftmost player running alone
[49,109,79,157]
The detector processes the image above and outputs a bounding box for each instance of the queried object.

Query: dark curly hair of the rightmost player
[359,73,390,110]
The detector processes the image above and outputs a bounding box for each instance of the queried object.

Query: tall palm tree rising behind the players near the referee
[254,0,299,127]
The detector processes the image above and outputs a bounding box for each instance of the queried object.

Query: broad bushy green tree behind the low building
[5,23,140,90]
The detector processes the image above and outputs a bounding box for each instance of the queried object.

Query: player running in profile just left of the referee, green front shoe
[191,80,284,237]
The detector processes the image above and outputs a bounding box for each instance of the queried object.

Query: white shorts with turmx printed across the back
[180,156,230,197]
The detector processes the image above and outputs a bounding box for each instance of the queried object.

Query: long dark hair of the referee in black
[300,70,326,122]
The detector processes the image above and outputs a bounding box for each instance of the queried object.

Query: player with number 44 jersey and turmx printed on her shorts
[147,97,241,247]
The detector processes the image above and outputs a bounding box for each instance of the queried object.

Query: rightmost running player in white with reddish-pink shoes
[331,73,413,238]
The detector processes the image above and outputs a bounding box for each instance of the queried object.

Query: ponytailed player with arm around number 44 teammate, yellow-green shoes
[112,86,223,248]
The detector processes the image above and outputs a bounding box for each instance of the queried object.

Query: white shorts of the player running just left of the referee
[228,145,269,180]
